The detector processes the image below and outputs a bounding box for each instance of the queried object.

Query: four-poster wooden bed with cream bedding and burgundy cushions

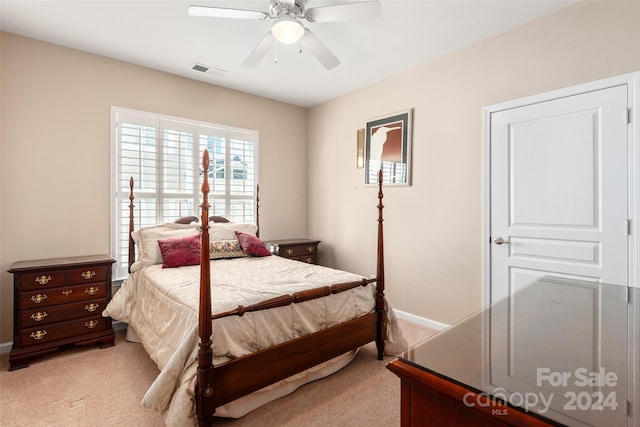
[103,151,405,426]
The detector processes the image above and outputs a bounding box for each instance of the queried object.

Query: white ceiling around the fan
[0,0,576,107]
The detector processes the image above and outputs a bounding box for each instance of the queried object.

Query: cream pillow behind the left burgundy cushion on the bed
[131,223,200,272]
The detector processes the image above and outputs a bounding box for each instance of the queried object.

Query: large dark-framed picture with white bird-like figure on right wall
[364,109,413,185]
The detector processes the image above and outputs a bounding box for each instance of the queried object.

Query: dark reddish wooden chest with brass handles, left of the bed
[9,255,115,370]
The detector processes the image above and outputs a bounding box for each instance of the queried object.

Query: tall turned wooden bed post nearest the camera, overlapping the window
[196,150,215,426]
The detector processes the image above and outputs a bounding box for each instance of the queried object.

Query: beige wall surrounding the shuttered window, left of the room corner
[0,33,308,343]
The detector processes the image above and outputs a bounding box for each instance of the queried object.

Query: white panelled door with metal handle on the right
[485,85,629,302]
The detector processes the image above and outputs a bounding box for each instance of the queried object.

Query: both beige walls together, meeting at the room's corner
[0,1,640,343]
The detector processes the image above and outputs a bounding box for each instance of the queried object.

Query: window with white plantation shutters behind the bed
[111,107,258,278]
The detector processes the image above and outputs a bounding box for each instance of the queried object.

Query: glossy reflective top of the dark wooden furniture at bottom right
[399,278,640,427]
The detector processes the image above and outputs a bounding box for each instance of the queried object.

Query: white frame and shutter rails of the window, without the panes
[110,106,259,280]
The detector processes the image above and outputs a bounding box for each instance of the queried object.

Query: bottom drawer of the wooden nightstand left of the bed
[20,316,110,346]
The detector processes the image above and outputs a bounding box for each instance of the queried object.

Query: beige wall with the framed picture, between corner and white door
[309,1,640,323]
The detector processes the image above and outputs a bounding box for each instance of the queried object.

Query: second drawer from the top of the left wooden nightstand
[20,283,107,310]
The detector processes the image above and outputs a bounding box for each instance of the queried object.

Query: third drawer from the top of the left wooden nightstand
[20,298,107,328]
